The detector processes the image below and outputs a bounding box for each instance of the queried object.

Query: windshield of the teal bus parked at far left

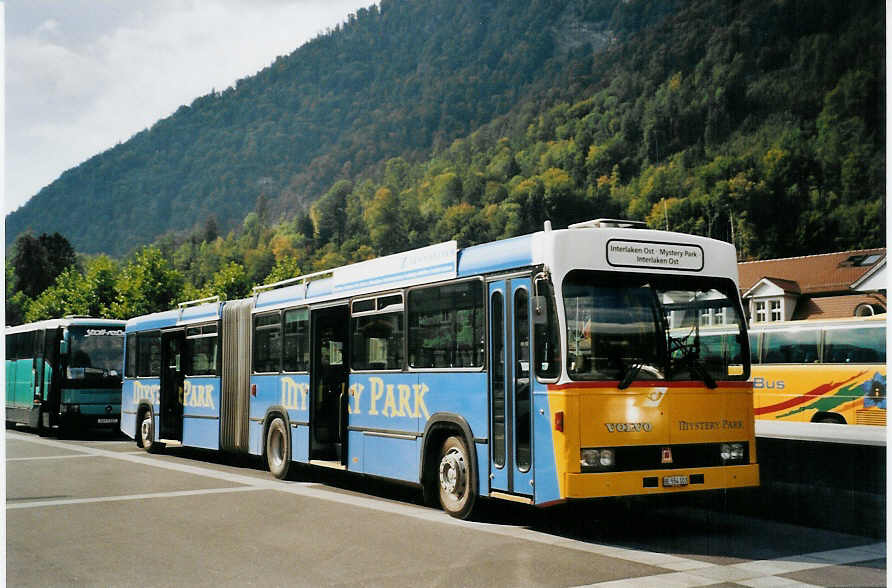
[68,326,124,382]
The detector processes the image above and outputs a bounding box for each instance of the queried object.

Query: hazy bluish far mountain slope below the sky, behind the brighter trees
[7,0,671,254]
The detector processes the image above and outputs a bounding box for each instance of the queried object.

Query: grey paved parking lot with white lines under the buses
[5,429,886,587]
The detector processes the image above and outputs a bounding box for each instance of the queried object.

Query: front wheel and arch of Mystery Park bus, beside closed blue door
[420,414,479,519]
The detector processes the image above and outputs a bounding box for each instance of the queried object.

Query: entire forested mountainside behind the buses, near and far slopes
[7,0,885,318]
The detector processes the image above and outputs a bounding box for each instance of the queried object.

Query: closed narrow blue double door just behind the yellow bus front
[489,278,533,496]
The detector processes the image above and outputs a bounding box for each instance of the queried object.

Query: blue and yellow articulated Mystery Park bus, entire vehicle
[121,219,759,518]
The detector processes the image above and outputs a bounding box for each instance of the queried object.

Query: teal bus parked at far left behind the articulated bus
[6,317,125,433]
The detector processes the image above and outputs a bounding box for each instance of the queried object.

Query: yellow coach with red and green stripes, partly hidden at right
[749,314,886,426]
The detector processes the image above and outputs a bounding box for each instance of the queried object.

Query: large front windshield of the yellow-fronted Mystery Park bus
[563,270,749,388]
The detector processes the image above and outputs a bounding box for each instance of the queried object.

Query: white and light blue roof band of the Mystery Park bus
[127,219,738,322]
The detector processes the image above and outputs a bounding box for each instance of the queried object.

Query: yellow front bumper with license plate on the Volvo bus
[564,464,759,498]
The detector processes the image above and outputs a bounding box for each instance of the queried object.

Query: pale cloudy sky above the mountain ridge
[2,0,375,213]
